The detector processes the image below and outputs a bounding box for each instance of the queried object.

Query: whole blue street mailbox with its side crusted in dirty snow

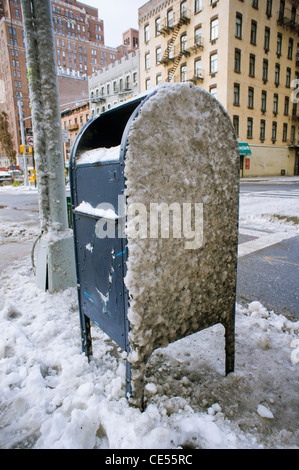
[70,83,239,406]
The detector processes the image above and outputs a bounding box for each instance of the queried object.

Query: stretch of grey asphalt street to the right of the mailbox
[237,181,299,319]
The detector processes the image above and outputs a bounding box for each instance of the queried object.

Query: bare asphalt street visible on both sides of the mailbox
[0,182,299,319]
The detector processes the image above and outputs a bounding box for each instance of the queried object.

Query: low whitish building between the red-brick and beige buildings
[88,50,139,117]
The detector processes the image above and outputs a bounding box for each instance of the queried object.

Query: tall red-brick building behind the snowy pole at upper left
[0,0,120,169]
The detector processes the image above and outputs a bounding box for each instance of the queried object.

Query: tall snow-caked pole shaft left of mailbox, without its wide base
[22,0,68,231]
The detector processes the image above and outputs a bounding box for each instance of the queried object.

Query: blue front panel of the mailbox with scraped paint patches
[74,163,127,350]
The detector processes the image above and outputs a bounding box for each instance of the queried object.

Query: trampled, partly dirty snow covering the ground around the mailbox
[0,182,299,449]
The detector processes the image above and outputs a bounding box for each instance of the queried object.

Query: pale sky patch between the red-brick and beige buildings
[82,0,147,47]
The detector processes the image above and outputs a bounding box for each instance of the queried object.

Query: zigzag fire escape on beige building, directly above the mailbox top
[160,10,203,82]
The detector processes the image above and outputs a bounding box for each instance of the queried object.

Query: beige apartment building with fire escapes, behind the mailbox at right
[139,0,299,177]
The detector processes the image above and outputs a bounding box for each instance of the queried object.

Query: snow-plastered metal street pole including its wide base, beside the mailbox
[21,0,76,292]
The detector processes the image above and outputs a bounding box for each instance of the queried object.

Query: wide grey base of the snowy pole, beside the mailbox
[36,230,77,292]
